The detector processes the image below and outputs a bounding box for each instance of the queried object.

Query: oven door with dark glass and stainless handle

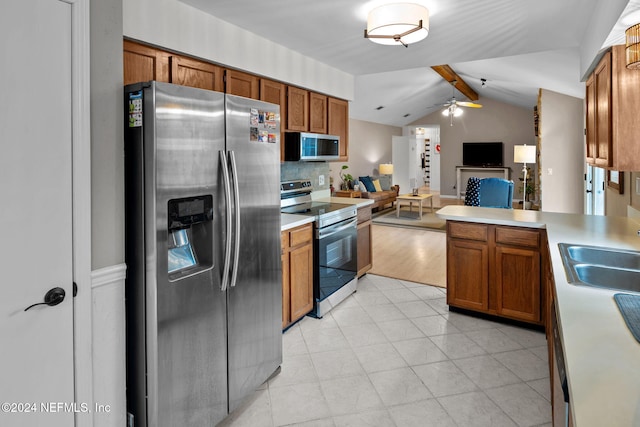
[313,218,358,302]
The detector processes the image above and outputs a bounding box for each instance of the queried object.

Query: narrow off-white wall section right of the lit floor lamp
[539,89,585,213]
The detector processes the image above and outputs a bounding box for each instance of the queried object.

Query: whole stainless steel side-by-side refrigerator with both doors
[125,82,282,426]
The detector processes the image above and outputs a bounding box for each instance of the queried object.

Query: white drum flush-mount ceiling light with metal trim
[364,3,429,47]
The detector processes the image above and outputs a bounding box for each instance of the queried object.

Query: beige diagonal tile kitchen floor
[221,274,551,427]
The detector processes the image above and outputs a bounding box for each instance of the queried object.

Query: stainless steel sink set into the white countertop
[558,243,640,292]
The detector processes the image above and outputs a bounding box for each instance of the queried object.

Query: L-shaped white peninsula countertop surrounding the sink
[437,206,640,427]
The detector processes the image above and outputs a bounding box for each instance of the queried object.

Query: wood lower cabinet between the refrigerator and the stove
[281,224,313,329]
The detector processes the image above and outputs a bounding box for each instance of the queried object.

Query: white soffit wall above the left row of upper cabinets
[123,0,354,100]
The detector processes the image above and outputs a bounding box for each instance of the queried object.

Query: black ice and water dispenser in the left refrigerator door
[167,195,213,281]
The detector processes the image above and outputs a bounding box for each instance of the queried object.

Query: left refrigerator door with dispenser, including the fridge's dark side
[125,82,228,426]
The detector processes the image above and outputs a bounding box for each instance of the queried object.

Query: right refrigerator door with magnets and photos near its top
[226,95,282,411]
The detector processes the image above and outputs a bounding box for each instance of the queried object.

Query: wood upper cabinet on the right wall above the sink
[586,45,640,171]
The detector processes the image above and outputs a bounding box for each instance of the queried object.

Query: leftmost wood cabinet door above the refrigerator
[122,40,169,85]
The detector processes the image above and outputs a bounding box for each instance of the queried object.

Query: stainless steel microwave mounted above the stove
[284,132,340,161]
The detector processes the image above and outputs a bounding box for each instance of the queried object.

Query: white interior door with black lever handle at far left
[0,0,74,427]
